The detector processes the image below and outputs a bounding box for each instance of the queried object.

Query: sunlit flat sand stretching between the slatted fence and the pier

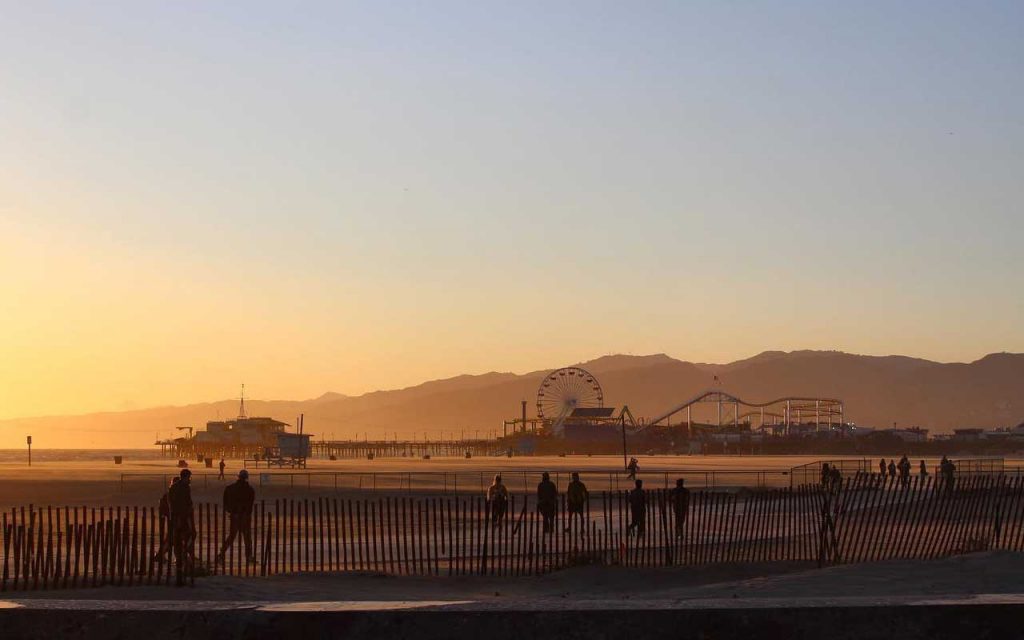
[0,456,983,508]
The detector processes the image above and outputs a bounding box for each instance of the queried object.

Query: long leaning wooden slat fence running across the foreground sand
[0,473,1024,591]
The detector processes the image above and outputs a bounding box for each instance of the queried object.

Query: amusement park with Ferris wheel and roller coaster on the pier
[504,367,844,436]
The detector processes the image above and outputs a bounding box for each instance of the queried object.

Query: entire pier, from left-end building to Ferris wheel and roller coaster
[157,367,844,466]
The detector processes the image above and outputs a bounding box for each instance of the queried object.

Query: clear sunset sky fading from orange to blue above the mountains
[0,1,1024,418]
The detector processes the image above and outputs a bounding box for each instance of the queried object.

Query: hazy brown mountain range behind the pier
[0,351,1024,449]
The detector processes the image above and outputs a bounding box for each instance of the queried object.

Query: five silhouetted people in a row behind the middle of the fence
[487,468,690,537]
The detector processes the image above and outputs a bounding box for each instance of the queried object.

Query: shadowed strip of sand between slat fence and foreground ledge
[9,552,1024,602]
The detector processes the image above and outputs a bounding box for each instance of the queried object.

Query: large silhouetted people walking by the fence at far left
[154,460,256,586]
